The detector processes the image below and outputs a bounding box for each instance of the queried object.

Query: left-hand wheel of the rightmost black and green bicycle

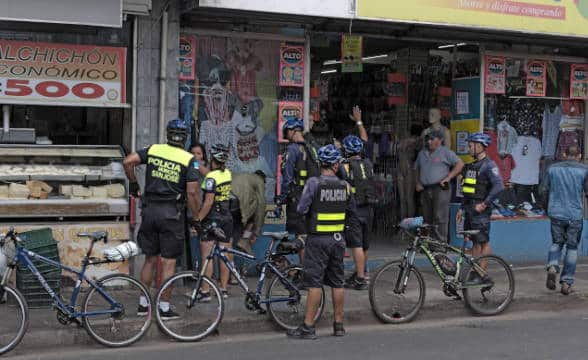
[369,260,425,324]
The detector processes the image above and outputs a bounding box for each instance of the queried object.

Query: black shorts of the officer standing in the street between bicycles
[302,234,345,288]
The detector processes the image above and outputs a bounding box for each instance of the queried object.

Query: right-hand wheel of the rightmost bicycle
[463,255,515,316]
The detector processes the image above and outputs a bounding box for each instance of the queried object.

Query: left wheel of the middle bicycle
[155,271,224,341]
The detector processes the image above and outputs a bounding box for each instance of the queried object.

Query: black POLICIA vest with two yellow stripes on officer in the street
[308,179,351,234]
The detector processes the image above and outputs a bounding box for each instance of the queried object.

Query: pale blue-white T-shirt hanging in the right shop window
[511,136,541,185]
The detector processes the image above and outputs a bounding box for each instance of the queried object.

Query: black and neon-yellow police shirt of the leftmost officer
[137,144,200,200]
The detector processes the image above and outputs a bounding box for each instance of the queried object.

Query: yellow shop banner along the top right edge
[357,0,588,37]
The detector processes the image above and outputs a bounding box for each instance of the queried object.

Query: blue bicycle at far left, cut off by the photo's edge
[0,228,151,355]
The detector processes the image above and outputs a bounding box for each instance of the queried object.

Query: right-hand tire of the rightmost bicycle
[462,255,515,316]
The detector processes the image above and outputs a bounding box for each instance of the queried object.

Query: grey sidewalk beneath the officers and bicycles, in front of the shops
[0,259,588,349]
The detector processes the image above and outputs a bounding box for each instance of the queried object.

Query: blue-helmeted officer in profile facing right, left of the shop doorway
[276,118,319,260]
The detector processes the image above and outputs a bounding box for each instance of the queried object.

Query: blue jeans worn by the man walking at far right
[547,218,583,285]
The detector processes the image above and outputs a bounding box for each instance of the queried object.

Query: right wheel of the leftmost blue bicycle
[82,274,152,347]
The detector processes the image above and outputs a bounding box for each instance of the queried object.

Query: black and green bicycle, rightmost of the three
[369,225,515,324]
